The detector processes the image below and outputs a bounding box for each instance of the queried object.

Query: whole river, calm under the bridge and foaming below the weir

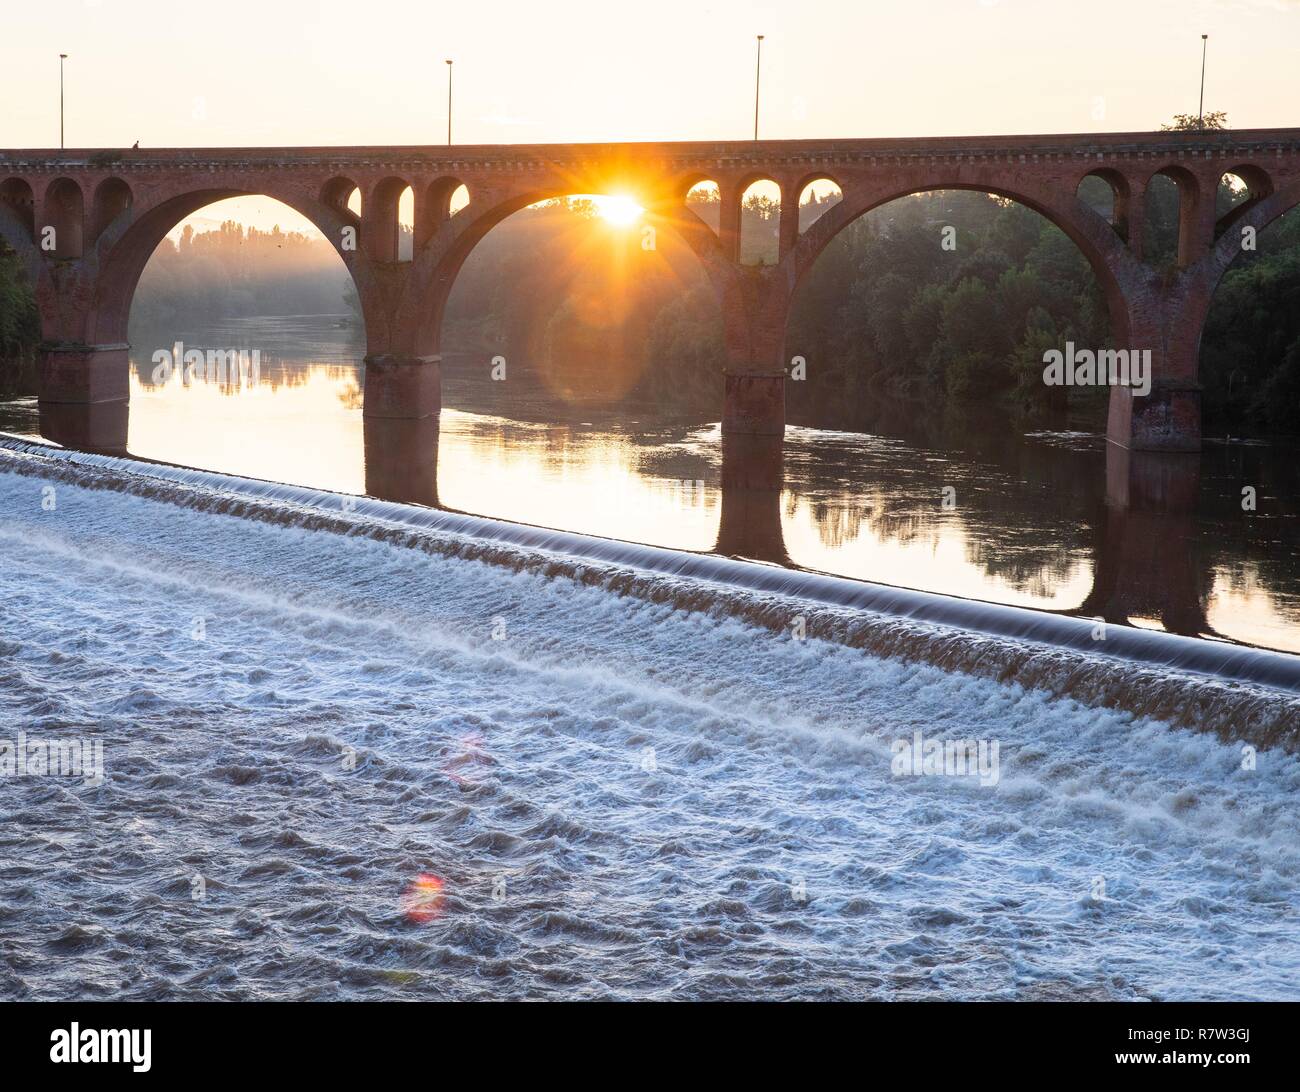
[0,320,1300,1000]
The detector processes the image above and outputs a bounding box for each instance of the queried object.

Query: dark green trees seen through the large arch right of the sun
[787,192,1108,416]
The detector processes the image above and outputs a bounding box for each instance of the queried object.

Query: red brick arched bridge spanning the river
[0,129,1300,451]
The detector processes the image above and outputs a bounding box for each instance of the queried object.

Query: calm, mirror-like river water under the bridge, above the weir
[0,315,1300,650]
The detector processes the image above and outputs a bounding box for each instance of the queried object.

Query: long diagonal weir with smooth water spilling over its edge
[0,423,1300,749]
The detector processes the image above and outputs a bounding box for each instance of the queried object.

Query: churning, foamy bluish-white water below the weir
[0,441,1300,1000]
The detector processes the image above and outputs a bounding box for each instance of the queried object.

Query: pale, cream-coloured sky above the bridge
[0,0,1300,230]
